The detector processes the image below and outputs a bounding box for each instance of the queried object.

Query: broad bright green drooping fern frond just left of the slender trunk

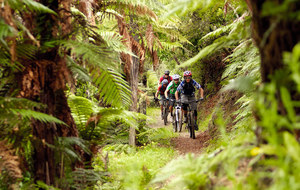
[91,69,131,107]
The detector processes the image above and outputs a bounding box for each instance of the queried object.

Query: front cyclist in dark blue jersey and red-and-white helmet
[175,71,203,130]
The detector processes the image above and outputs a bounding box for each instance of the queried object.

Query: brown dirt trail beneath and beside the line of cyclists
[149,108,210,155]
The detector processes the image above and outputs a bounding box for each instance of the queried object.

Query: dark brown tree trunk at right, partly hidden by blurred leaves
[250,0,300,141]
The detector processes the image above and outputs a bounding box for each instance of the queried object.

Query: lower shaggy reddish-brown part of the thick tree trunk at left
[18,58,78,185]
